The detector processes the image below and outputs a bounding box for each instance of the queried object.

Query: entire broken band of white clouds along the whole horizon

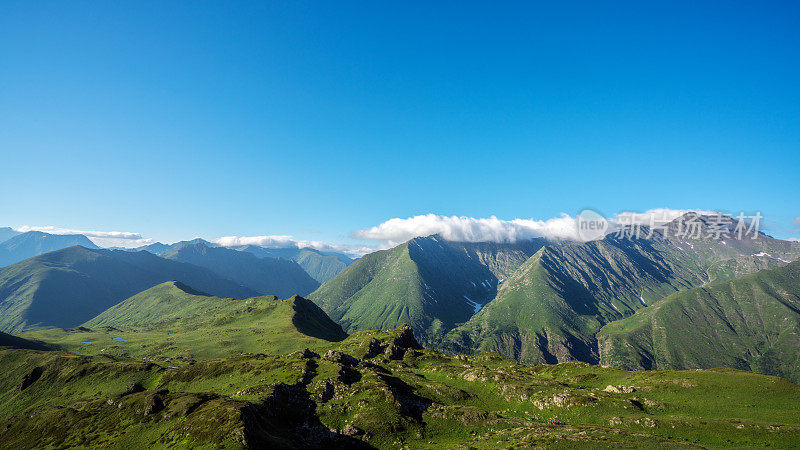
[16,208,736,257]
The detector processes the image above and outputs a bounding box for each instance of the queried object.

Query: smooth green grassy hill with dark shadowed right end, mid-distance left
[23,282,347,362]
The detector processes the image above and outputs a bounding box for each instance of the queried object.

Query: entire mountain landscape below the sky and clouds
[0,213,800,448]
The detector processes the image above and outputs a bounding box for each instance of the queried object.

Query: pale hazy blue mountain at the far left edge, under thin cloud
[0,231,98,267]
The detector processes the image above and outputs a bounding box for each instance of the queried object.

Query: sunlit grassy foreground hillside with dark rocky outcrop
[0,329,800,449]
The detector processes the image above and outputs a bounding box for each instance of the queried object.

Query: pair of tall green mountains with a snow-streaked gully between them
[310,213,800,367]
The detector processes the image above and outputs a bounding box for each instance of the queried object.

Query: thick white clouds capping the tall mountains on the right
[353,208,711,246]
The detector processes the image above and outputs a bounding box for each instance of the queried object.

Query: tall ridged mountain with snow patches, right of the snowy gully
[441,212,800,363]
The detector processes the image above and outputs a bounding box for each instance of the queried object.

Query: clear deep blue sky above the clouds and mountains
[0,1,800,245]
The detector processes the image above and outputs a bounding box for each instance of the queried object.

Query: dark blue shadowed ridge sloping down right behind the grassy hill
[161,241,319,297]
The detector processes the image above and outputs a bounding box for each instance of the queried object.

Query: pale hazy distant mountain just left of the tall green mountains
[236,245,353,283]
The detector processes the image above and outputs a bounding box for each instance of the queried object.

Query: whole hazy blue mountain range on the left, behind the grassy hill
[0,228,351,332]
